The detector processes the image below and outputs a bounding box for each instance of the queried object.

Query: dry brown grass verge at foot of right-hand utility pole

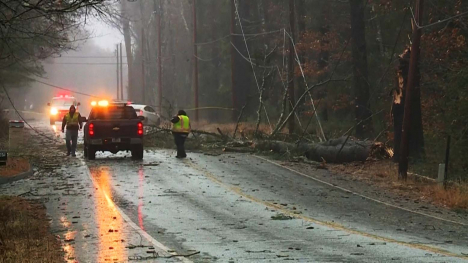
[327,160,468,211]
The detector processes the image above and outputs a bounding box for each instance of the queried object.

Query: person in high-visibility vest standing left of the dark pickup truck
[62,105,83,157]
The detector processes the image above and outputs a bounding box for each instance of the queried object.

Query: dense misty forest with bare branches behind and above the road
[0,0,468,178]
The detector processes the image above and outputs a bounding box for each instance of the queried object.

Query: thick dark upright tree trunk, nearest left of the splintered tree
[349,0,372,138]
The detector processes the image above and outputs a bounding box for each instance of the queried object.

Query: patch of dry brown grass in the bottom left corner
[0,196,64,263]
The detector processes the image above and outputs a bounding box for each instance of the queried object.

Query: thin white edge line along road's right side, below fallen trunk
[253,155,468,226]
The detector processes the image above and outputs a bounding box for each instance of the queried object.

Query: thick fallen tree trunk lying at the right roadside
[255,137,391,163]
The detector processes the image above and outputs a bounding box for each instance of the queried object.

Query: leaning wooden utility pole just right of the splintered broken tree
[398,0,424,181]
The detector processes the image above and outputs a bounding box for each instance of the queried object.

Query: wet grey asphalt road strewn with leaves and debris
[0,122,468,262]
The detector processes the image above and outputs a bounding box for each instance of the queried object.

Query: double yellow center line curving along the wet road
[186,160,468,260]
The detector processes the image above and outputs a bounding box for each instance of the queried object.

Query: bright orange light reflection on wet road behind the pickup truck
[91,167,128,262]
